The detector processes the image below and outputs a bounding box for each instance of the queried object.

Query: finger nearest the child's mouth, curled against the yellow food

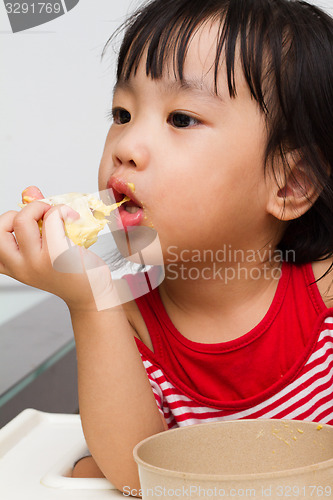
[42,205,84,273]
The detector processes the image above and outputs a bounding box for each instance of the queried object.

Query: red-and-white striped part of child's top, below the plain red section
[136,314,333,429]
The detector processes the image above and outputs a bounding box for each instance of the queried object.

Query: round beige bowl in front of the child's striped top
[133,420,333,500]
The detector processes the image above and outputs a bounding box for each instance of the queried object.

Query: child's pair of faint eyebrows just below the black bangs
[113,78,223,101]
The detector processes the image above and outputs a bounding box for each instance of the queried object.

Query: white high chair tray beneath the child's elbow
[0,409,123,500]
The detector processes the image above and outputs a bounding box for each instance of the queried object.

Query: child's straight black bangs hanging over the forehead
[106,0,284,112]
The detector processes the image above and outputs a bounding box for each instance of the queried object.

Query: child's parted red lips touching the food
[107,177,143,229]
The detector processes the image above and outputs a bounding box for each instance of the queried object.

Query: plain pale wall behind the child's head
[0,0,333,290]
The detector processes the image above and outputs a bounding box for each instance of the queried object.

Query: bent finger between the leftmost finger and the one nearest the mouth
[14,201,51,259]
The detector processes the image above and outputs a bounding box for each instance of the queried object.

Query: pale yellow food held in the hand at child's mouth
[20,190,129,248]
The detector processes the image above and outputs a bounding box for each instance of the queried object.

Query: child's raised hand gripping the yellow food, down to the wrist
[0,187,116,310]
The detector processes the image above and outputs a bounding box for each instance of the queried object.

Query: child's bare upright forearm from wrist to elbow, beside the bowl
[71,307,165,490]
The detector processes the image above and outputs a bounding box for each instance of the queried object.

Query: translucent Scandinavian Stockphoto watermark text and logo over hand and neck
[38,190,295,311]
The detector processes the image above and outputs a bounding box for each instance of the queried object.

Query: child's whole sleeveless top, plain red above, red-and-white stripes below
[129,263,333,429]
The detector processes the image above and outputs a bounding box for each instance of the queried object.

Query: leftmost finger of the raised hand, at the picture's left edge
[0,210,19,274]
